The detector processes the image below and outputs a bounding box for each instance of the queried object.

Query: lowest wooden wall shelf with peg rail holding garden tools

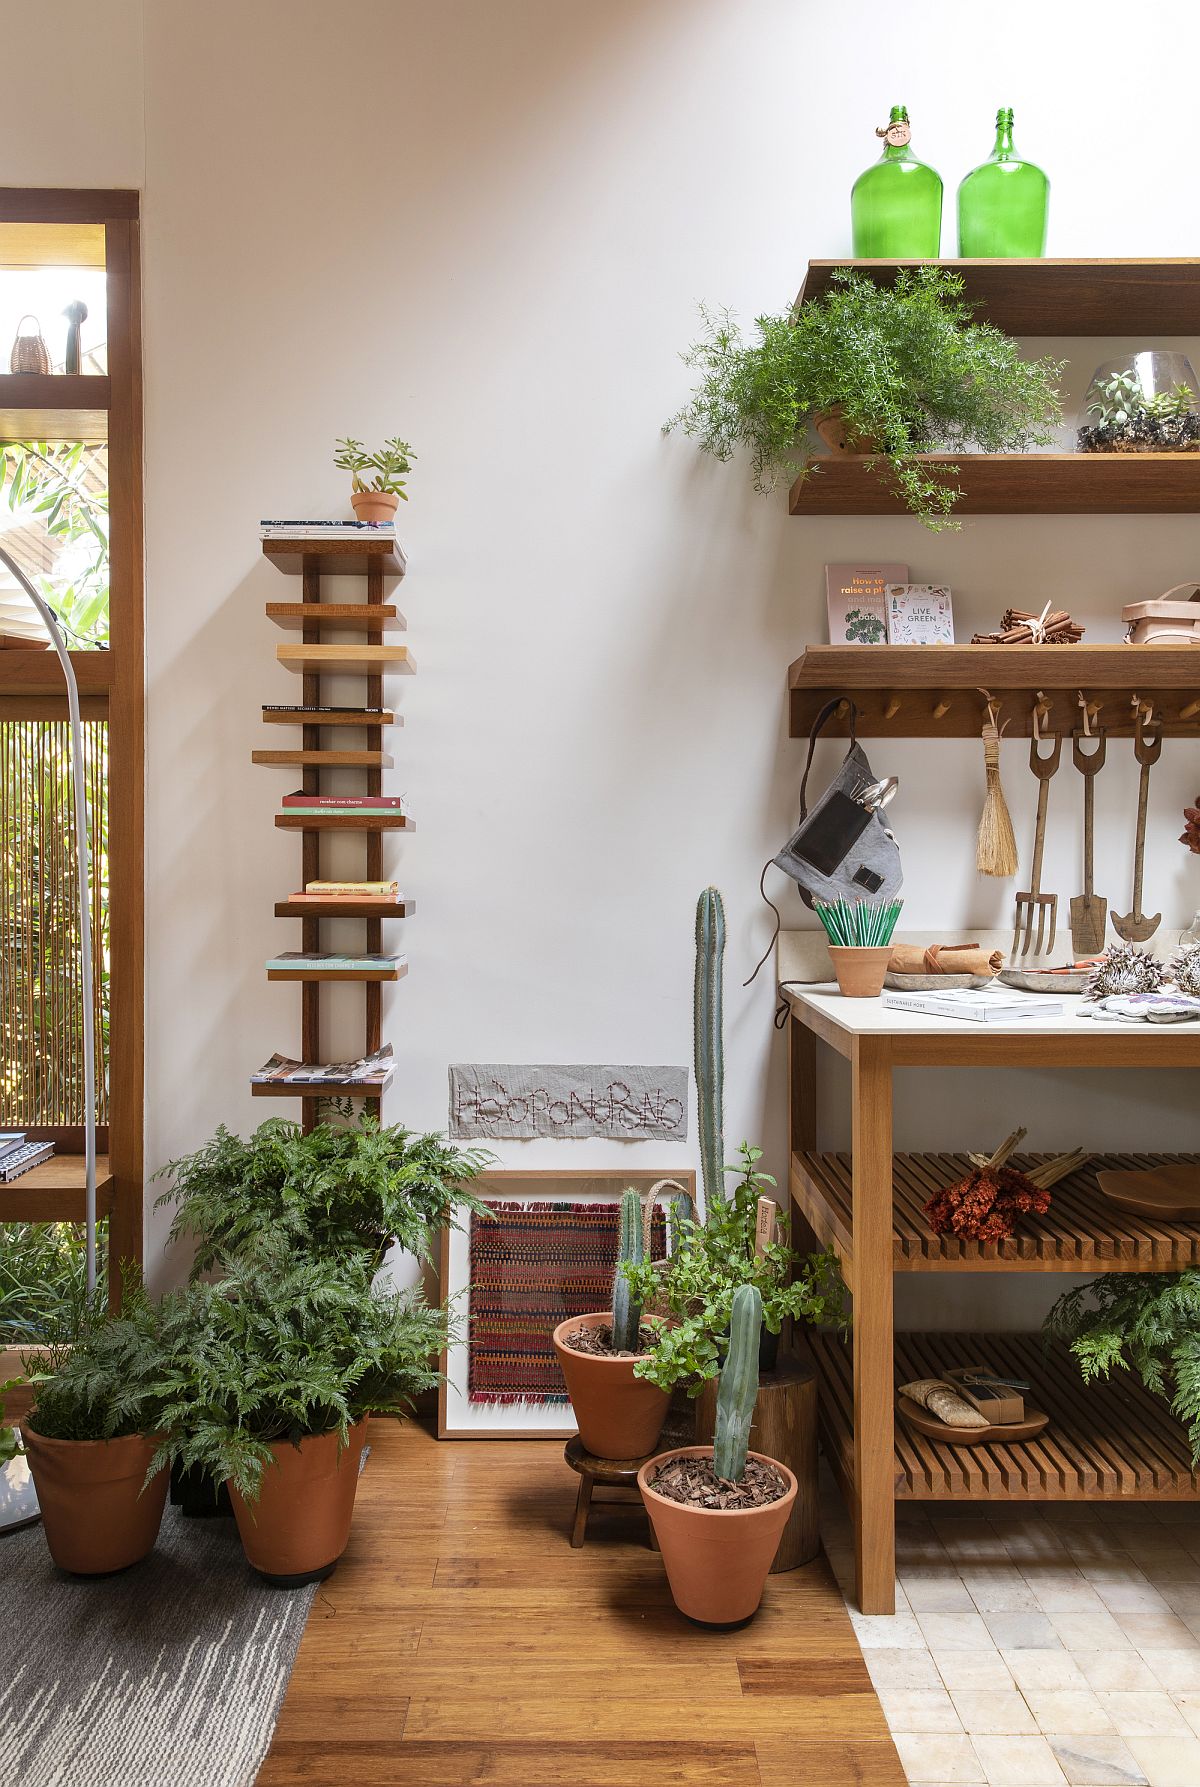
[788,646,1200,738]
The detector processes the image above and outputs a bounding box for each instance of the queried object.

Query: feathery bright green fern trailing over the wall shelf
[666,266,1063,531]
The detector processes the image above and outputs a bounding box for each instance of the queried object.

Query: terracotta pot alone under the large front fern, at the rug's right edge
[229,1421,366,1589]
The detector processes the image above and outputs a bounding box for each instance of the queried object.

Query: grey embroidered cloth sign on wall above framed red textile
[450,1061,688,1142]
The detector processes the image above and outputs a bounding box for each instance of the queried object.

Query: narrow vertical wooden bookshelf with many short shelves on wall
[252,533,414,1129]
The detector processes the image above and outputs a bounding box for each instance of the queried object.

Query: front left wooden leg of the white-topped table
[850,1036,896,1614]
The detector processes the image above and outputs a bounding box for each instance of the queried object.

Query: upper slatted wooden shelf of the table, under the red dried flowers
[791,1154,1200,1272]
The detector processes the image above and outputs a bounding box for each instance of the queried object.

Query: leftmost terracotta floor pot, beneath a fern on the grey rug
[21,1426,168,1576]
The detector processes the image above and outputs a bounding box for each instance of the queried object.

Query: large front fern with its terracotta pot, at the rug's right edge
[154,1242,450,1589]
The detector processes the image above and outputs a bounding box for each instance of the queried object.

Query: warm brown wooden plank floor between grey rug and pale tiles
[259,1422,904,1787]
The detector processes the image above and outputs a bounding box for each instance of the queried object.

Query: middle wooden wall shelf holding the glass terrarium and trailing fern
[788,452,1200,515]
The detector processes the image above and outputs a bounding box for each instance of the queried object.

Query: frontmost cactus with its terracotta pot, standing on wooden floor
[638,1285,796,1626]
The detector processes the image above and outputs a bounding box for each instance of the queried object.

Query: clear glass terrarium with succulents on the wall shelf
[1079,350,1200,452]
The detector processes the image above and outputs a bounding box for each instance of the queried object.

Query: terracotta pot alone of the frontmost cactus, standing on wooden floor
[638,1446,796,1626]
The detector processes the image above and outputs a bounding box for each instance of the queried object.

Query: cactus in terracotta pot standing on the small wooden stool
[554,1188,671,1458]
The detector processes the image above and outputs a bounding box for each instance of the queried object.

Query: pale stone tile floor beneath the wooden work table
[821,1487,1200,1787]
